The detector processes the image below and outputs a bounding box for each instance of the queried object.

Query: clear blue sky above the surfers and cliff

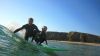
[0,0,100,35]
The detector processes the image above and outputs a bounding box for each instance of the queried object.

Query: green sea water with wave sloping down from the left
[0,26,100,56]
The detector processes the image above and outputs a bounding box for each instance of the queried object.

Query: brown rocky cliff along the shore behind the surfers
[47,32,100,43]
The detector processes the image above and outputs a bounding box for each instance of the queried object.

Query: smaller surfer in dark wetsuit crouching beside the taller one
[35,26,48,45]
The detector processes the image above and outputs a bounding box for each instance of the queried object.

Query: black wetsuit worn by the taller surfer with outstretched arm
[14,24,40,41]
